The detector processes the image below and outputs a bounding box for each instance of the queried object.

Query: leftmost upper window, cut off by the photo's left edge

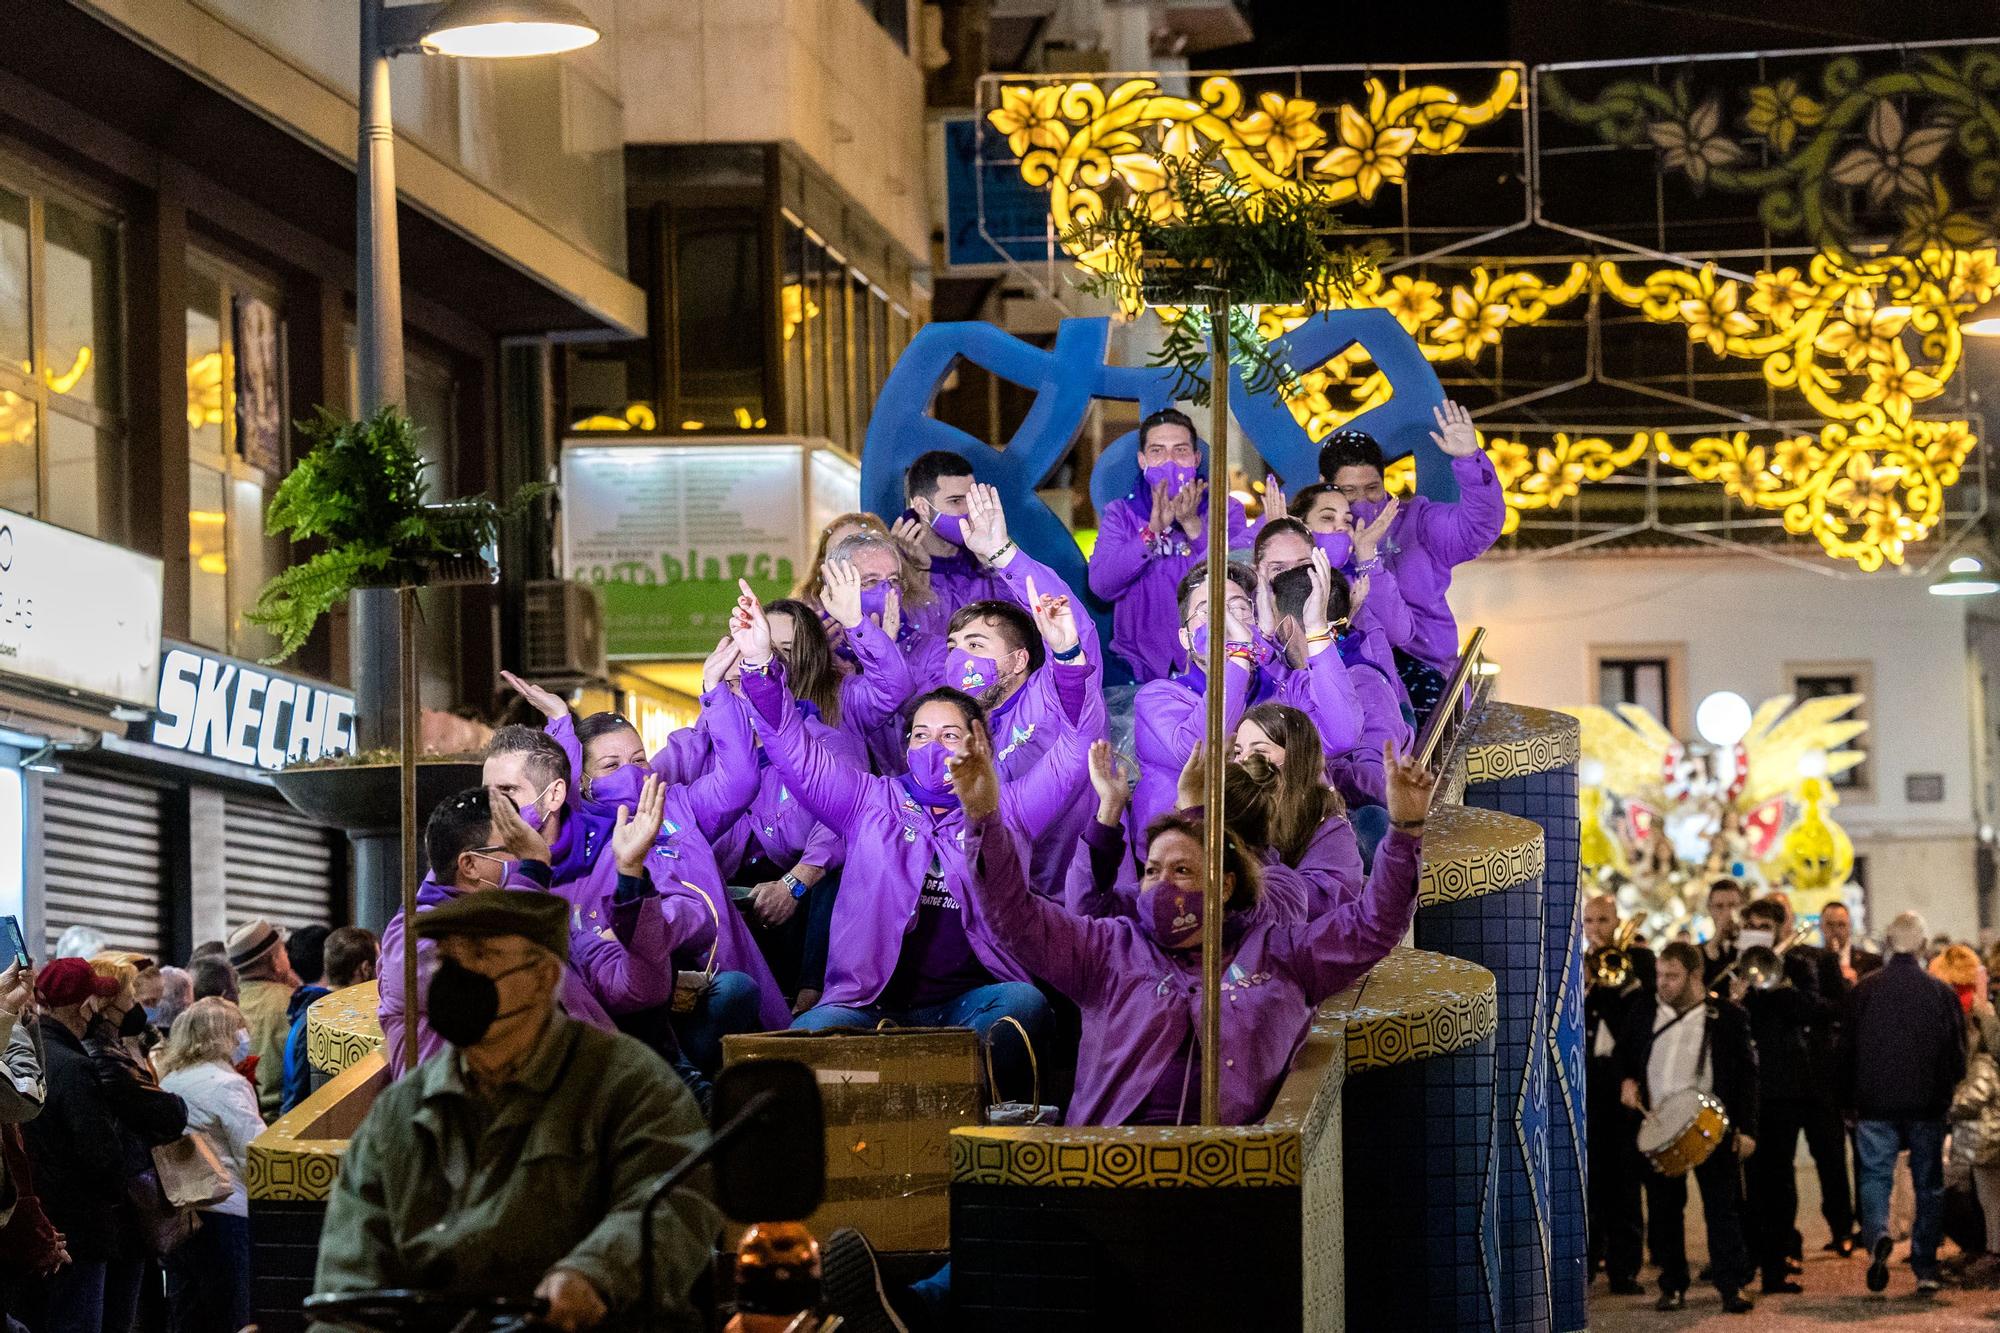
[0,176,126,540]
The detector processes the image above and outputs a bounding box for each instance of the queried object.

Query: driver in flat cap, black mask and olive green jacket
[316,889,720,1333]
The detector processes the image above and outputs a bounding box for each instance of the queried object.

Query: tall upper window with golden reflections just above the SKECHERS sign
[186,256,290,658]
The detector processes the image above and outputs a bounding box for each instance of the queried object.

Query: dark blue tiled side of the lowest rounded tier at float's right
[1340,1037,1500,1333]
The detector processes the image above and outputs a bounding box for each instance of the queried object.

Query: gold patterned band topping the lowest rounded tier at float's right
[1322,949,1500,1075]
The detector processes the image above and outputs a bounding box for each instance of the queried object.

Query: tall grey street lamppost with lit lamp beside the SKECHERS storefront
[348,0,602,929]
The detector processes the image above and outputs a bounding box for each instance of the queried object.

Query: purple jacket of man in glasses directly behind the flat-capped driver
[376,851,674,1077]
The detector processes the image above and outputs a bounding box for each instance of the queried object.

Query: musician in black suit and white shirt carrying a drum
[1618,941,1756,1315]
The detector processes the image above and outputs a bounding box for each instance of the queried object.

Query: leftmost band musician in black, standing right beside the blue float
[1584,893,1654,1295]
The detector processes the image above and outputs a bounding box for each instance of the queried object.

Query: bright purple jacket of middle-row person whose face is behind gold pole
[1132,646,1368,829]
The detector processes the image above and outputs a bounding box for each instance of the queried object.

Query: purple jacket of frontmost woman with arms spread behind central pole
[960,821,1422,1125]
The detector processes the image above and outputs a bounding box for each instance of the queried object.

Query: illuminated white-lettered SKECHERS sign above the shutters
[150,644,354,769]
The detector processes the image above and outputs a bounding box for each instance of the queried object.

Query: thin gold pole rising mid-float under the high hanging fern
[1202,292,1234,1125]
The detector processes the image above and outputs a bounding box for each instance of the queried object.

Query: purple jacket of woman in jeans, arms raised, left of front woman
[744,667,1086,1005]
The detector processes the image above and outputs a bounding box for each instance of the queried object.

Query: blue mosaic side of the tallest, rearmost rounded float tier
[1466,765,1590,1333]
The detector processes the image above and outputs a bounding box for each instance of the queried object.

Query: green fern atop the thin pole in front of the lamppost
[248,406,548,664]
